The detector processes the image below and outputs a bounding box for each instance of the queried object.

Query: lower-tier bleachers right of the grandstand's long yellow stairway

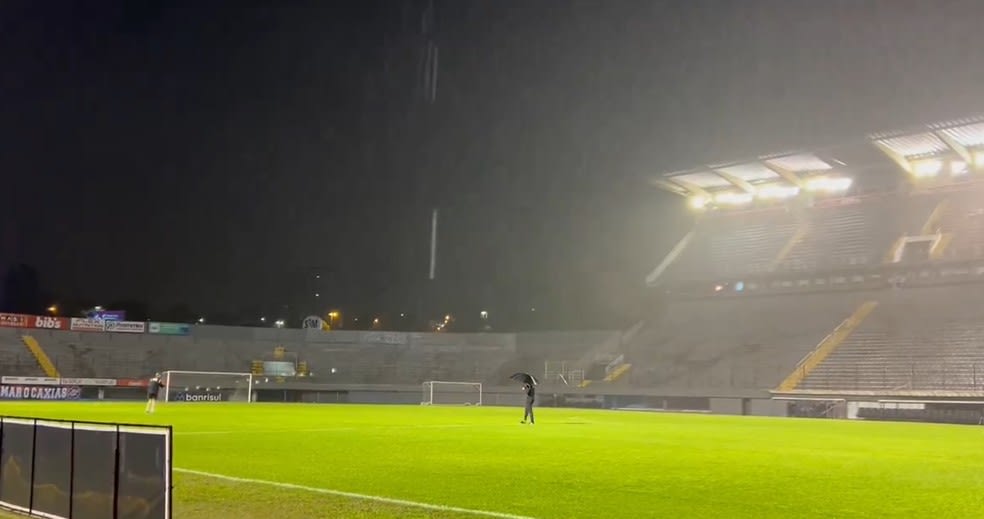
[798,286,984,392]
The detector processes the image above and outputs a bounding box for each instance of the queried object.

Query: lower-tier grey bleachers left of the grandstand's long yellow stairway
[627,292,870,393]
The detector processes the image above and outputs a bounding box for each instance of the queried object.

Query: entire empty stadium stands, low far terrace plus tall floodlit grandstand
[0,119,984,423]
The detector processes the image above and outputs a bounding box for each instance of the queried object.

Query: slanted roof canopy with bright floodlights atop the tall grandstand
[649,116,984,208]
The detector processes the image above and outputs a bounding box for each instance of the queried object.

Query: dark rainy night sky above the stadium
[0,0,984,330]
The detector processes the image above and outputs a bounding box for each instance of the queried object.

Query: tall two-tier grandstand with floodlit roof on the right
[636,118,984,416]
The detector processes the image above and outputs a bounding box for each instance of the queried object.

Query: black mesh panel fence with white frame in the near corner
[0,417,172,519]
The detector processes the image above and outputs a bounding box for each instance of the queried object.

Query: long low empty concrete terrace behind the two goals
[19,326,613,384]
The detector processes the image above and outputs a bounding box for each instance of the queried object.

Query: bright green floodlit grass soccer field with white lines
[0,402,984,519]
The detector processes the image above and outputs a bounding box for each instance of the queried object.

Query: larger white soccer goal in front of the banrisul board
[161,371,253,402]
